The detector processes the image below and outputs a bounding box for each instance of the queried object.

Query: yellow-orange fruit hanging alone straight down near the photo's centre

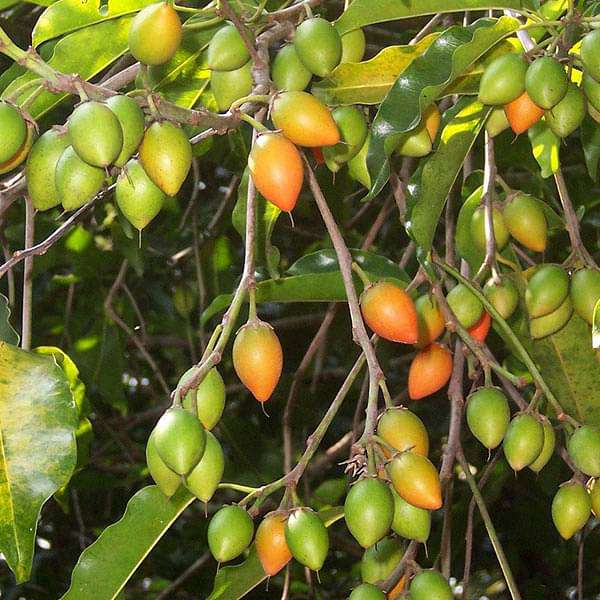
[233,321,283,402]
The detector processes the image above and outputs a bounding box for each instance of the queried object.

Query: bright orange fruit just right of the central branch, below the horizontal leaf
[360,281,419,344]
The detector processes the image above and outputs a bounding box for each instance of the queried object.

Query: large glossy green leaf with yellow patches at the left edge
[0,342,77,582]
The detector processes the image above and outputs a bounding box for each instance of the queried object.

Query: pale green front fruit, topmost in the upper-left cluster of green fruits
[68,101,123,167]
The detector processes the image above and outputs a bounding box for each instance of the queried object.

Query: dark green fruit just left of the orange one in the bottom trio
[206,504,254,563]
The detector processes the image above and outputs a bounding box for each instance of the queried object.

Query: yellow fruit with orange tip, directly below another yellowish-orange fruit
[388,452,442,510]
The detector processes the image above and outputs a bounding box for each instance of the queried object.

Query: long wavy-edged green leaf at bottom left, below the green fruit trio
[61,485,194,600]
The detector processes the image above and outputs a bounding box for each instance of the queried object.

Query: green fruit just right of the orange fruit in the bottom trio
[285,508,329,571]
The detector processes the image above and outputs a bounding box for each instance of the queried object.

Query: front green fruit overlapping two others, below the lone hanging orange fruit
[154,408,206,475]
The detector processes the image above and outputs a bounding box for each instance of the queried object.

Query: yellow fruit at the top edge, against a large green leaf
[129,2,181,65]
